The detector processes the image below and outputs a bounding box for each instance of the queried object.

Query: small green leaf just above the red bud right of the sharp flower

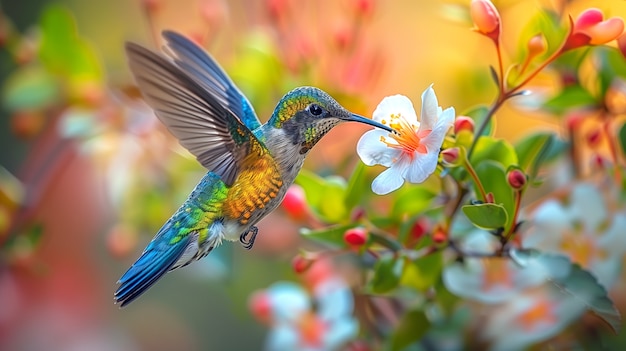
[515,132,556,178]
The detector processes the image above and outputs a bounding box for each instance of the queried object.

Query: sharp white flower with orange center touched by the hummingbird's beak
[357,86,454,195]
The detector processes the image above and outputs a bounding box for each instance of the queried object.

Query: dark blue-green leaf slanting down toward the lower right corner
[538,254,621,333]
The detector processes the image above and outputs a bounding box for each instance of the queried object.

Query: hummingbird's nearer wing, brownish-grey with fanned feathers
[126,43,266,186]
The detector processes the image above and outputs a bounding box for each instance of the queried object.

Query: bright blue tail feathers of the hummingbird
[115,229,190,307]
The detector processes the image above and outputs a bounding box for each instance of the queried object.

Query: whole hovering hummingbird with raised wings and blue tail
[114,31,393,307]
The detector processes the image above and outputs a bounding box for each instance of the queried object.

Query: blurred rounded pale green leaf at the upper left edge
[2,65,59,111]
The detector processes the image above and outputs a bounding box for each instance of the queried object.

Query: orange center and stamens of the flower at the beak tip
[380,114,431,159]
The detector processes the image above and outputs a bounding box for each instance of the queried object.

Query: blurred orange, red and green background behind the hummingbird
[0,0,626,350]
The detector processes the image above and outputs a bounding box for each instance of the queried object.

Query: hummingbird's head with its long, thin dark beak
[268,87,393,154]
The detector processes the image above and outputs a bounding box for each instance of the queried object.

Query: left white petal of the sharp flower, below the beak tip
[356,129,401,167]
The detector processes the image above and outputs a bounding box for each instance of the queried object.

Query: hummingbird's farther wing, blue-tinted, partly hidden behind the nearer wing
[163,31,261,130]
